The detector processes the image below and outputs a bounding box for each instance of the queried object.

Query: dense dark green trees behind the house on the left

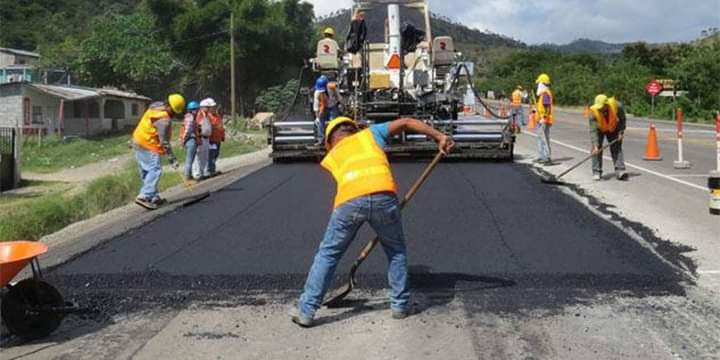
[0,0,315,112]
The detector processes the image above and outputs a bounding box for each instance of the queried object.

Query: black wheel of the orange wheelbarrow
[0,279,65,340]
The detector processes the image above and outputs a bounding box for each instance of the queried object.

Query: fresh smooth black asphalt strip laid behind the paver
[50,161,680,297]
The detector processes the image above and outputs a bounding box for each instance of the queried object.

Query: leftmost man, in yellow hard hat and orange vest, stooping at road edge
[132,94,185,209]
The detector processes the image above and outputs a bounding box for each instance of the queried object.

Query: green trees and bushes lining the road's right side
[476,35,720,122]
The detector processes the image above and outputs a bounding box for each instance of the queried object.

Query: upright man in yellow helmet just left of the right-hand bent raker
[535,74,555,165]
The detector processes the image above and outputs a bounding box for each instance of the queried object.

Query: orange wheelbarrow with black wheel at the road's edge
[0,241,77,339]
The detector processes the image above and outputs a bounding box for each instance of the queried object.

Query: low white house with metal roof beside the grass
[0,82,150,137]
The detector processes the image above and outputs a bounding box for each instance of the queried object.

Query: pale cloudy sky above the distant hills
[306,0,720,44]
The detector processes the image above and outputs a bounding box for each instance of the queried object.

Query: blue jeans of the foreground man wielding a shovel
[298,193,410,319]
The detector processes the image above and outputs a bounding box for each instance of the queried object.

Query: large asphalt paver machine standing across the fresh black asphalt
[268,0,515,160]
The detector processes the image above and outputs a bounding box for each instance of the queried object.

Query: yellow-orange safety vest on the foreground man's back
[320,129,397,208]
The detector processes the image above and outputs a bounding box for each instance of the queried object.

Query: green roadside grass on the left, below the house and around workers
[0,124,265,241]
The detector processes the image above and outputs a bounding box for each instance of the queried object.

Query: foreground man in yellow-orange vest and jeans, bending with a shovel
[292,116,453,327]
